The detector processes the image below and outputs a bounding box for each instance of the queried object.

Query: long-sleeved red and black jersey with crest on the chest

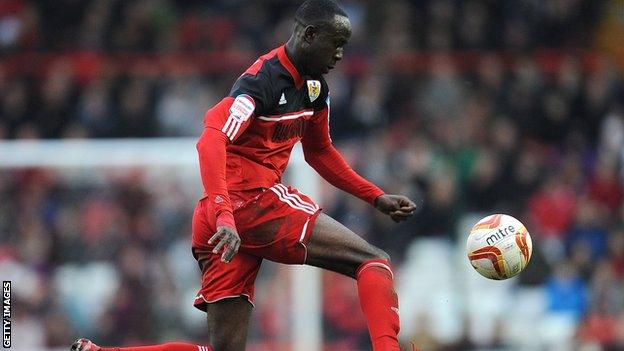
[197,46,383,228]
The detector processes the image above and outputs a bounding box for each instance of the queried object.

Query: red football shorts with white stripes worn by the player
[192,184,320,311]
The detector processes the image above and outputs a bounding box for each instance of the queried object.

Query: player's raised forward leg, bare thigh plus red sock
[305,213,399,351]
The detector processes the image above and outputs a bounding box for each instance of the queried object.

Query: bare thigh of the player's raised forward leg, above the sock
[305,213,390,277]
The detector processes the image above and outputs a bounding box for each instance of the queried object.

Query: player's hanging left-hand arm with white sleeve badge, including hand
[196,69,268,262]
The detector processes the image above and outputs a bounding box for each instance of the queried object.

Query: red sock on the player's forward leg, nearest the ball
[355,259,400,351]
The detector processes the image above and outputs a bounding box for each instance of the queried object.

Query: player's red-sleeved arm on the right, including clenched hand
[301,99,416,222]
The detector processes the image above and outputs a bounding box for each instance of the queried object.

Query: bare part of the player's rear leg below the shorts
[206,297,252,351]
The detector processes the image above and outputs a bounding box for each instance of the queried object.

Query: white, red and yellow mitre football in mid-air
[466,214,533,280]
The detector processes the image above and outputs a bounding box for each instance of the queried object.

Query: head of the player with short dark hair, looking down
[293,0,351,75]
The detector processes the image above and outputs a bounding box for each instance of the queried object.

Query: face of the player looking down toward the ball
[308,15,351,74]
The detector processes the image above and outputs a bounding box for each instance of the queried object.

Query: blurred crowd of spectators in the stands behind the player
[0,0,624,350]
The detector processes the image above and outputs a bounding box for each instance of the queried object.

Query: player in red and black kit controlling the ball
[73,0,416,351]
